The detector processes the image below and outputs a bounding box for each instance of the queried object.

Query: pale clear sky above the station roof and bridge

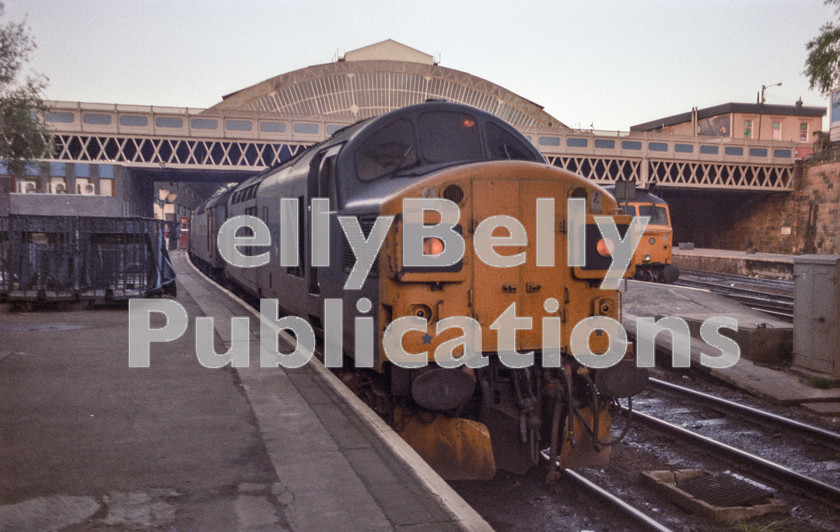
[3,0,840,131]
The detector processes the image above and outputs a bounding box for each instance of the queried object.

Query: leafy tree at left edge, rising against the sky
[0,0,49,173]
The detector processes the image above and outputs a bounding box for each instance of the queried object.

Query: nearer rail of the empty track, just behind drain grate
[622,407,840,507]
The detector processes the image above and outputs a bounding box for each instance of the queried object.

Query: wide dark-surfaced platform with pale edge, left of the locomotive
[0,252,490,531]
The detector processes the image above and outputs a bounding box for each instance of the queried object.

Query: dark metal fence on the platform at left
[0,215,175,302]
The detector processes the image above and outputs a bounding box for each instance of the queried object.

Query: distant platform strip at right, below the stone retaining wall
[671,247,794,281]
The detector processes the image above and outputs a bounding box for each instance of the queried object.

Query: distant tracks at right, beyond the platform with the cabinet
[675,270,793,321]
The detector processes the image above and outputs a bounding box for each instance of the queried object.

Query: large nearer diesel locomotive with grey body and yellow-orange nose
[190,101,647,479]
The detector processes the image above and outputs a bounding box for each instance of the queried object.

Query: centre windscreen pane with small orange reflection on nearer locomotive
[419,111,484,164]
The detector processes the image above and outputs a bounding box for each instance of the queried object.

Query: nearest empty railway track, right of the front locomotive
[633,379,840,508]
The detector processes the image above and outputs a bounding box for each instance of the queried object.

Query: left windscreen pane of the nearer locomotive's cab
[356,118,418,181]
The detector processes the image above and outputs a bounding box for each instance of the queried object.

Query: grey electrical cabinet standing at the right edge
[793,255,840,379]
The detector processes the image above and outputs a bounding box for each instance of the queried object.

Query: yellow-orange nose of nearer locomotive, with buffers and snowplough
[377,162,644,479]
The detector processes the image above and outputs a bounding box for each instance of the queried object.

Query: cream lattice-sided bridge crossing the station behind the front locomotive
[41,102,797,192]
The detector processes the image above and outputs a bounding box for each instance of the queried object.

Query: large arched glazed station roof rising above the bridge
[208,40,566,127]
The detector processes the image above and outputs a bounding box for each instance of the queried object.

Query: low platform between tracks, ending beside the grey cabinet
[622,280,840,416]
